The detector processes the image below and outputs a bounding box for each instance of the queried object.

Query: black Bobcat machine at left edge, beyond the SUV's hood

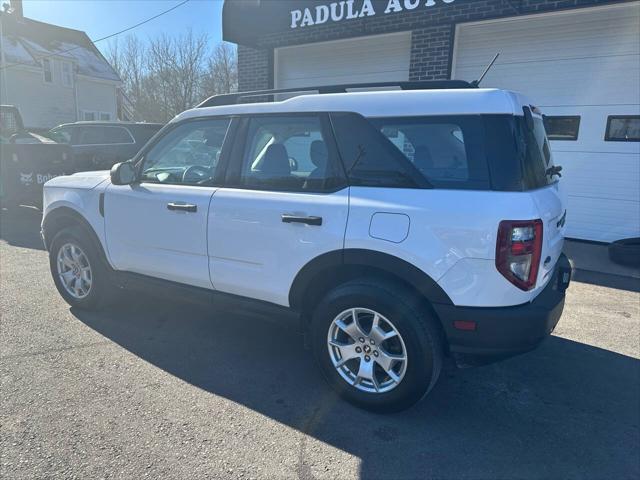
[0,105,77,209]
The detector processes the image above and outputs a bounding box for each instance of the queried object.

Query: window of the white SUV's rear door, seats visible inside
[240,114,343,192]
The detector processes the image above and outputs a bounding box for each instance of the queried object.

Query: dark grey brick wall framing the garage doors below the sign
[238,0,632,90]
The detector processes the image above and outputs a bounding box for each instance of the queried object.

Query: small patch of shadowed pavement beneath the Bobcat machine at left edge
[0,207,44,250]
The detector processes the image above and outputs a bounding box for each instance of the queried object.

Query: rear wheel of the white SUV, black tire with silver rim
[311,279,443,413]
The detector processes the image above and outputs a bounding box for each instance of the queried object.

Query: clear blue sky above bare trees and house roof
[21,0,223,51]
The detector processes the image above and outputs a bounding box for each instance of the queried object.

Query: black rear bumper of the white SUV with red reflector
[434,254,572,363]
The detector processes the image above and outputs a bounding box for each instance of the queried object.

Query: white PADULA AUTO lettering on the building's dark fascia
[290,0,455,28]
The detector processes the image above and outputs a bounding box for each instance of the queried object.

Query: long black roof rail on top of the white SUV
[197,80,477,108]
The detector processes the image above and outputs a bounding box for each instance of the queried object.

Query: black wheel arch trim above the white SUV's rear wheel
[289,248,453,310]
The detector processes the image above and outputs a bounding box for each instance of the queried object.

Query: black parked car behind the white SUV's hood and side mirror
[47,122,162,171]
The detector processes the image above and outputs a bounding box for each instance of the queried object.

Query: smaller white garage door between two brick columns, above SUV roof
[274,32,411,88]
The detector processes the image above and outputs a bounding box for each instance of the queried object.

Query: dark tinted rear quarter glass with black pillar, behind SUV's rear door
[331,113,556,191]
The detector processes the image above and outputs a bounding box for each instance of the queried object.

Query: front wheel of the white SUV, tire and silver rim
[49,227,115,310]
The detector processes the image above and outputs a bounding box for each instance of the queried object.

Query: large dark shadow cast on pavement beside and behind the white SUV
[72,297,640,479]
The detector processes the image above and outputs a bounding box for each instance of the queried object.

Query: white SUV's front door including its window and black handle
[104,119,229,288]
